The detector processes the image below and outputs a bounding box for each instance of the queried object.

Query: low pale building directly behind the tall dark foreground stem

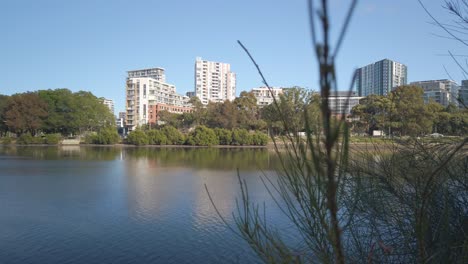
[328,91,364,116]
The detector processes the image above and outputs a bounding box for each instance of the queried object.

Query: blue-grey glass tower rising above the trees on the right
[355,59,408,96]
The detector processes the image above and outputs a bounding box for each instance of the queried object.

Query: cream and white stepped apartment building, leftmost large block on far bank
[125,68,192,131]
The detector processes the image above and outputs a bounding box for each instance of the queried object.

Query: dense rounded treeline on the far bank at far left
[0,89,115,137]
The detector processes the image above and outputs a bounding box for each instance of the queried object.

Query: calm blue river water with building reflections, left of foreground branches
[0,146,288,263]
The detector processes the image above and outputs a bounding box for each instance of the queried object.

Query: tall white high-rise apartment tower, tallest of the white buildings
[195,57,236,105]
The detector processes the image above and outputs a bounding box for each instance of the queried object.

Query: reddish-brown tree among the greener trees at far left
[5,92,48,136]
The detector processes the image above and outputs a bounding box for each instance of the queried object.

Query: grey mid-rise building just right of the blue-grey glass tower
[411,79,460,107]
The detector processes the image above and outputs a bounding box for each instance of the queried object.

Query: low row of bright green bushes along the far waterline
[127,125,268,146]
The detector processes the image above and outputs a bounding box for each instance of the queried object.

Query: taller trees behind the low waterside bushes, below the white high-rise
[158,87,319,135]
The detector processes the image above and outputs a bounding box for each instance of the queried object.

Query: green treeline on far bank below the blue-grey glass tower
[352,86,468,136]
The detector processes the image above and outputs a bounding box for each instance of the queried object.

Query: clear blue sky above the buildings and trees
[0,0,460,114]
